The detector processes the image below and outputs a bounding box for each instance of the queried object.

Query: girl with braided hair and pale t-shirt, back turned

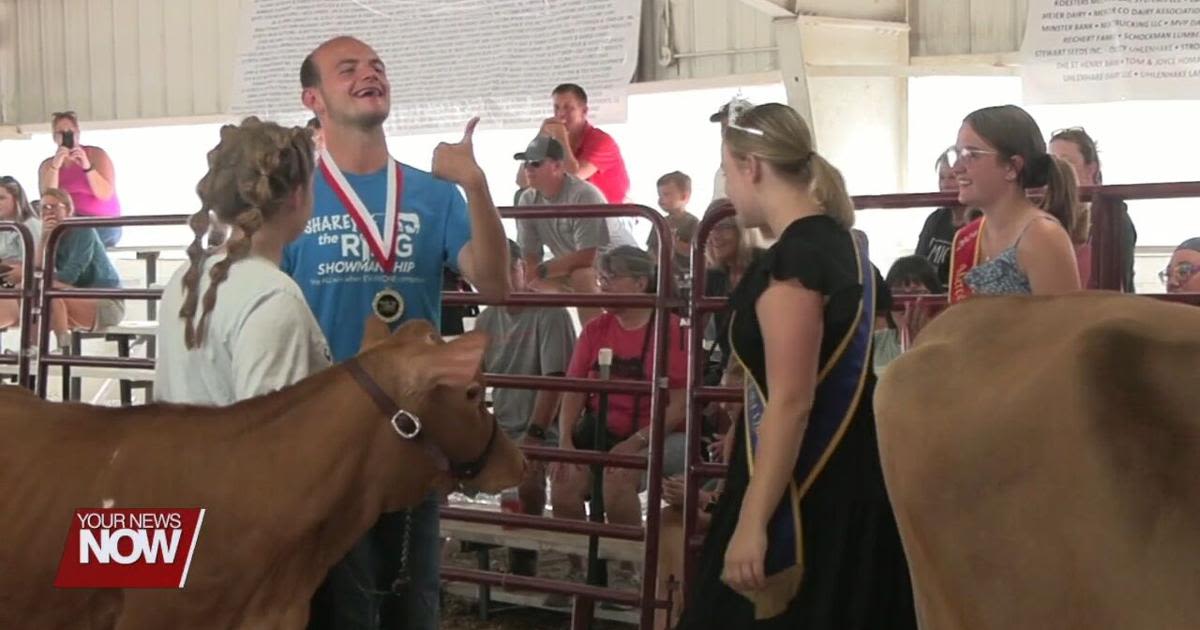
[155,118,330,404]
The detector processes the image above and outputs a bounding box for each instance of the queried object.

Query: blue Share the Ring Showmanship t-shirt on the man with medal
[282,164,470,361]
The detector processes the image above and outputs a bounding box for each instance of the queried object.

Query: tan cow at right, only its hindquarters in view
[875,293,1200,630]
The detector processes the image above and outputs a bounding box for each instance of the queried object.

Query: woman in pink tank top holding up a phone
[37,112,121,247]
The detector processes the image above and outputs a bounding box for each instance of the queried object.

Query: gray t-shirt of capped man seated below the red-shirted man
[517,174,636,260]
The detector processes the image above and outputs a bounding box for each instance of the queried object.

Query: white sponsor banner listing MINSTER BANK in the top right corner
[1021,0,1200,104]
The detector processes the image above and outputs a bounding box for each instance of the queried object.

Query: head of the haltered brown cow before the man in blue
[360,318,526,492]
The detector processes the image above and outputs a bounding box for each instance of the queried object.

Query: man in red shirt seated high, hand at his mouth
[532,83,629,204]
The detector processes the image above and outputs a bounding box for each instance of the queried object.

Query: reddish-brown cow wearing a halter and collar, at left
[0,322,524,630]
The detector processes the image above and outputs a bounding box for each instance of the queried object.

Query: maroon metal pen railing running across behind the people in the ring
[21,182,1200,628]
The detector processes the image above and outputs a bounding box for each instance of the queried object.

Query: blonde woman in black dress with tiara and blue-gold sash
[678,102,916,630]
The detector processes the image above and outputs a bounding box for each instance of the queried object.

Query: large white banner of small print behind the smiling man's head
[233,0,641,133]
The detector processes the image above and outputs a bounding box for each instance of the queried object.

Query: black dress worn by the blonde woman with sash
[677,216,917,630]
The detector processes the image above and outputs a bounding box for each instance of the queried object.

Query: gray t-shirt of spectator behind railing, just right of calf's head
[475,306,575,443]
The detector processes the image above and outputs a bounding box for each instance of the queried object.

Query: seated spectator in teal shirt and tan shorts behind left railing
[0,188,125,348]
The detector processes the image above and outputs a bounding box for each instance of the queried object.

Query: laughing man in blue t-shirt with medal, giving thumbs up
[282,37,509,630]
